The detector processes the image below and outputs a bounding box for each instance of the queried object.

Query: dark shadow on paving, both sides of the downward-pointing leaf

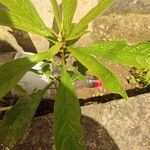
[14,114,119,150]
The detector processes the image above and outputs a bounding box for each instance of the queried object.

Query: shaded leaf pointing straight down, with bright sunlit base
[54,68,85,150]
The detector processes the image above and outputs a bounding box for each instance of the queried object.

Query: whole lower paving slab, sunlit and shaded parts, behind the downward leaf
[9,94,150,150]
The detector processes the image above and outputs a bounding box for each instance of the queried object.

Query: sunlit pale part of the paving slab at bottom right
[82,94,150,150]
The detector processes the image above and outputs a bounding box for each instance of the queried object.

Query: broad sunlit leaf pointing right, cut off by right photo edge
[77,41,150,69]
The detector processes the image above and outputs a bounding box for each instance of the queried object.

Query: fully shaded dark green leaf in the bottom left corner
[0,91,43,149]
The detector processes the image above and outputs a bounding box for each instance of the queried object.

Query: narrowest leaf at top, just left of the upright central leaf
[51,0,61,30]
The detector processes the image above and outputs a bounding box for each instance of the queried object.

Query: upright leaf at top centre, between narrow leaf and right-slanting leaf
[62,0,77,32]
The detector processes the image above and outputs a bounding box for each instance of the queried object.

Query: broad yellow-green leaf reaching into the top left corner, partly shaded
[0,0,54,37]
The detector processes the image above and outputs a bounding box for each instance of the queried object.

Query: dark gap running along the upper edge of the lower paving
[0,87,150,119]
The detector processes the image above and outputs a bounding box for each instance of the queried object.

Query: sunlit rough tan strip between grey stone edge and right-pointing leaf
[91,13,150,42]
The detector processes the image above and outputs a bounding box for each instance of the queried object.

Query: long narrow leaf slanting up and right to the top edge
[68,0,114,40]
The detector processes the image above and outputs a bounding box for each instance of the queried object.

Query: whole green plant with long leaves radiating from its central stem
[0,0,150,150]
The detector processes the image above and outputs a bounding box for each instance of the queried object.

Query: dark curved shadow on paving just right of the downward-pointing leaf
[82,116,119,150]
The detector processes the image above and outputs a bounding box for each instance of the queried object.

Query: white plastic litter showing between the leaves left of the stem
[11,52,56,99]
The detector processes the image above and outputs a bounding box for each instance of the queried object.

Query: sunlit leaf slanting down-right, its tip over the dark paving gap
[69,48,127,98]
